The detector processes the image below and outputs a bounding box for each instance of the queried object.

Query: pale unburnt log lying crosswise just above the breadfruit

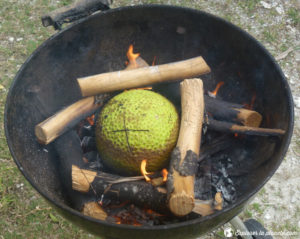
[77,56,210,96]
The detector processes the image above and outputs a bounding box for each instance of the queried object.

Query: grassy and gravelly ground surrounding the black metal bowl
[0,0,300,239]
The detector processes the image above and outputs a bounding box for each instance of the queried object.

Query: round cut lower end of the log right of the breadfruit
[169,192,195,217]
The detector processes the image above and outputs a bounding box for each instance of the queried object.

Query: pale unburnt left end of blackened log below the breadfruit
[72,165,97,192]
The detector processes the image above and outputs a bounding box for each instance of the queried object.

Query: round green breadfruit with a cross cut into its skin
[96,90,179,175]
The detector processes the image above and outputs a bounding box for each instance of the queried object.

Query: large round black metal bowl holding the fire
[5,5,294,239]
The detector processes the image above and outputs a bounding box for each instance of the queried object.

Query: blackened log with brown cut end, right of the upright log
[205,96,262,127]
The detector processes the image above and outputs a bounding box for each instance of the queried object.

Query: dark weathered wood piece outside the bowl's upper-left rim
[41,0,112,30]
